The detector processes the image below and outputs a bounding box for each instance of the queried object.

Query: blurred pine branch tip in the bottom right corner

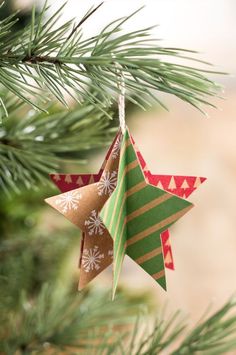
[125,299,236,355]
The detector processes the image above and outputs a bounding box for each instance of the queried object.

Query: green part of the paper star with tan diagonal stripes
[100,130,193,297]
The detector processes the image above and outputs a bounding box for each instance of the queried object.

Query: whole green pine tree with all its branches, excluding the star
[0,2,236,354]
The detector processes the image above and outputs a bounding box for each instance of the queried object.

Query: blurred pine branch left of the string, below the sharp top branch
[0,92,113,193]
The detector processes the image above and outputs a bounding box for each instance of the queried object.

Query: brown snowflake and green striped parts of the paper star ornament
[46,130,202,296]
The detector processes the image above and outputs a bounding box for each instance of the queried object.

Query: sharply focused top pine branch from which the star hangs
[0,3,223,115]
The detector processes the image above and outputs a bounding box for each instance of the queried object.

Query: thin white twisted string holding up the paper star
[112,55,126,134]
